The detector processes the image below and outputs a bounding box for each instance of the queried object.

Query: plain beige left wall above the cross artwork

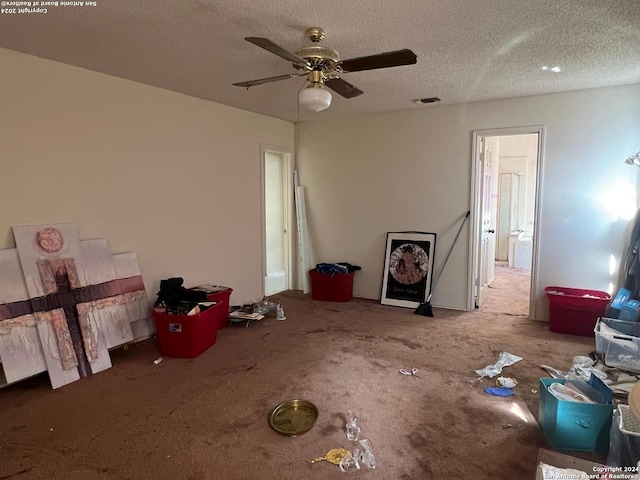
[0,49,294,303]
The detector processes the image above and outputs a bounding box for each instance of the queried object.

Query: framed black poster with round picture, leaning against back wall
[380,232,436,308]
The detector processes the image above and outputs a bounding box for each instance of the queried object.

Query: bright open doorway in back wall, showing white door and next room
[469,126,544,318]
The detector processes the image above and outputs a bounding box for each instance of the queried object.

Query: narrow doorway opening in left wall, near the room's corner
[262,147,293,296]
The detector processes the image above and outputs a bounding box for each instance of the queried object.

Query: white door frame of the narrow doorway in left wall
[260,143,295,296]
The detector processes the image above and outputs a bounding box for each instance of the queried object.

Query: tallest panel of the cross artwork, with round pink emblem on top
[13,223,111,388]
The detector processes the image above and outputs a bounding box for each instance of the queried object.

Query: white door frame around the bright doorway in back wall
[467,125,545,319]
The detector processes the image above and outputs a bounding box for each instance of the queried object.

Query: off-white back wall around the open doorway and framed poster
[298,85,640,317]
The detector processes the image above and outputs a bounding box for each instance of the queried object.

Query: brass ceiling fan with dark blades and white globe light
[233,27,417,112]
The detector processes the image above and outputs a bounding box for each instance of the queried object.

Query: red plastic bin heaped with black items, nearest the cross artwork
[153,303,223,358]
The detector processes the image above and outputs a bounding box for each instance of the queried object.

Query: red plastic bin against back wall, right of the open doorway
[544,287,611,337]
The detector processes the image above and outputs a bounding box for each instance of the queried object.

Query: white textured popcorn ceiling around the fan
[0,0,640,121]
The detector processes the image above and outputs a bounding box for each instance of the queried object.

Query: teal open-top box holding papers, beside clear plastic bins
[538,375,614,452]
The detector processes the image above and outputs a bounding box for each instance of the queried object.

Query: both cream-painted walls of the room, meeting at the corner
[0,49,640,313]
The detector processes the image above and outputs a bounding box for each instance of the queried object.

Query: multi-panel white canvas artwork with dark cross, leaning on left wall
[0,223,153,388]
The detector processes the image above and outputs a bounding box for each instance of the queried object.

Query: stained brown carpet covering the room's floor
[0,268,594,480]
